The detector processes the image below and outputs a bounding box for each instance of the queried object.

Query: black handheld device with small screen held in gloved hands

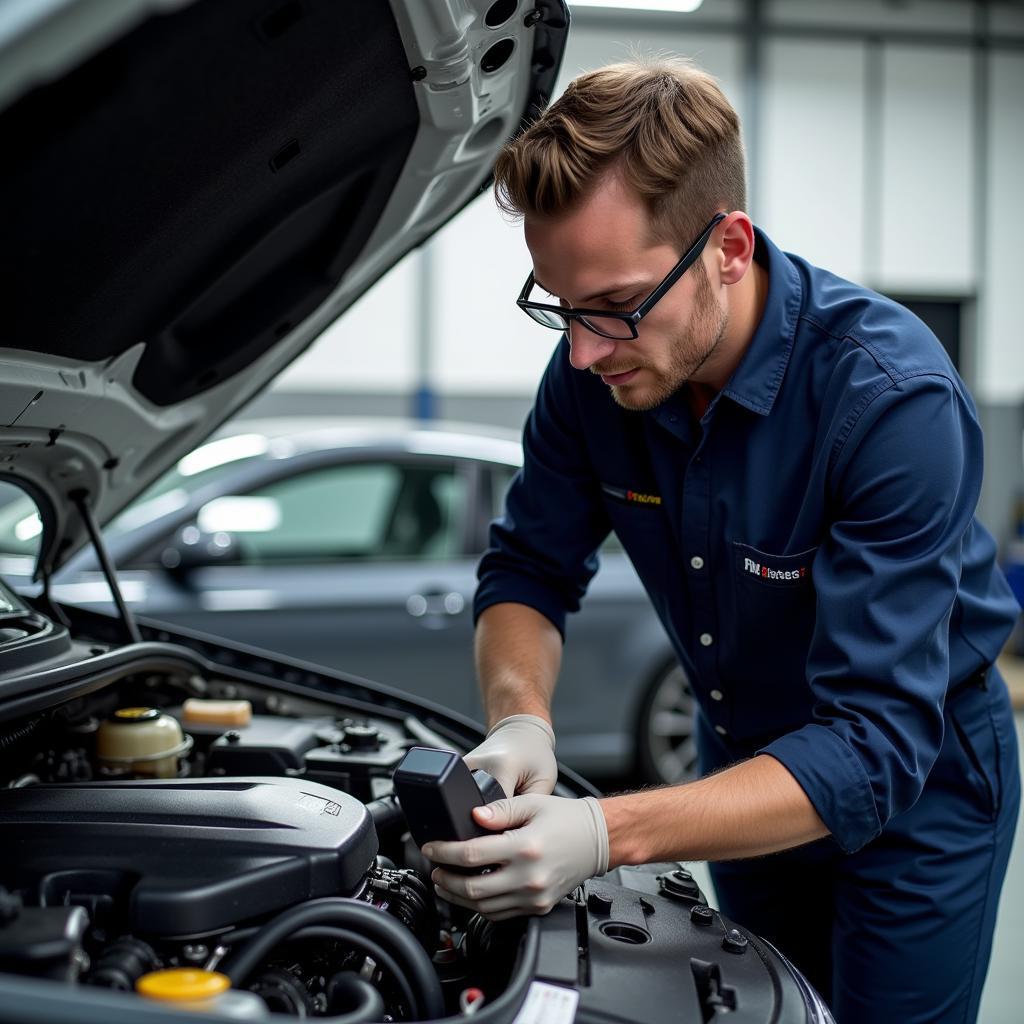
[393,746,505,846]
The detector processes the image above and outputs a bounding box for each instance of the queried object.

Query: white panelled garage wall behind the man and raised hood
[253,0,1024,538]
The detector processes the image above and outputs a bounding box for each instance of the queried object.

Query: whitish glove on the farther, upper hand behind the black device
[463,715,558,797]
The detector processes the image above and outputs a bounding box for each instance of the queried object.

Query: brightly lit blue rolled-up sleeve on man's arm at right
[758,374,982,852]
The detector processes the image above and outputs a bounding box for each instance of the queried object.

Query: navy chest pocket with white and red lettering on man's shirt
[722,541,818,692]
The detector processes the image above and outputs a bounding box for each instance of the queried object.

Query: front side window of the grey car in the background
[189,462,465,565]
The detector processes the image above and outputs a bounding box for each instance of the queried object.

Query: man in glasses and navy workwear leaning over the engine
[424,60,1020,1024]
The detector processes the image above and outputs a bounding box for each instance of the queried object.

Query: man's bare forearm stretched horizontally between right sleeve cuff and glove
[601,754,828,867]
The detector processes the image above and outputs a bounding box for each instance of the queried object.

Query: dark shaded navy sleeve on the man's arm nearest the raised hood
[473,339,610,637]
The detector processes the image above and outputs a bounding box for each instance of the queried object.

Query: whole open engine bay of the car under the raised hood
[0,609,827,1024]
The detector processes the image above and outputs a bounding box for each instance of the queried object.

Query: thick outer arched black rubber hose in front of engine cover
[220,896,444,1018]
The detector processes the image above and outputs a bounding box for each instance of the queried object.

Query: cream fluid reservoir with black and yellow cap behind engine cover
[96,708,191,778]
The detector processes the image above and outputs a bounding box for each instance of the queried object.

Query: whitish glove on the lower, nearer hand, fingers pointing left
[423,795,608,921]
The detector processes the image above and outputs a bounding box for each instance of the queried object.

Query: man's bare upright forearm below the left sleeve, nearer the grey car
[476,602,562,727]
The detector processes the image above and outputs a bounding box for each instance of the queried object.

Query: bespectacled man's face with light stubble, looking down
[525,175,727,410]
